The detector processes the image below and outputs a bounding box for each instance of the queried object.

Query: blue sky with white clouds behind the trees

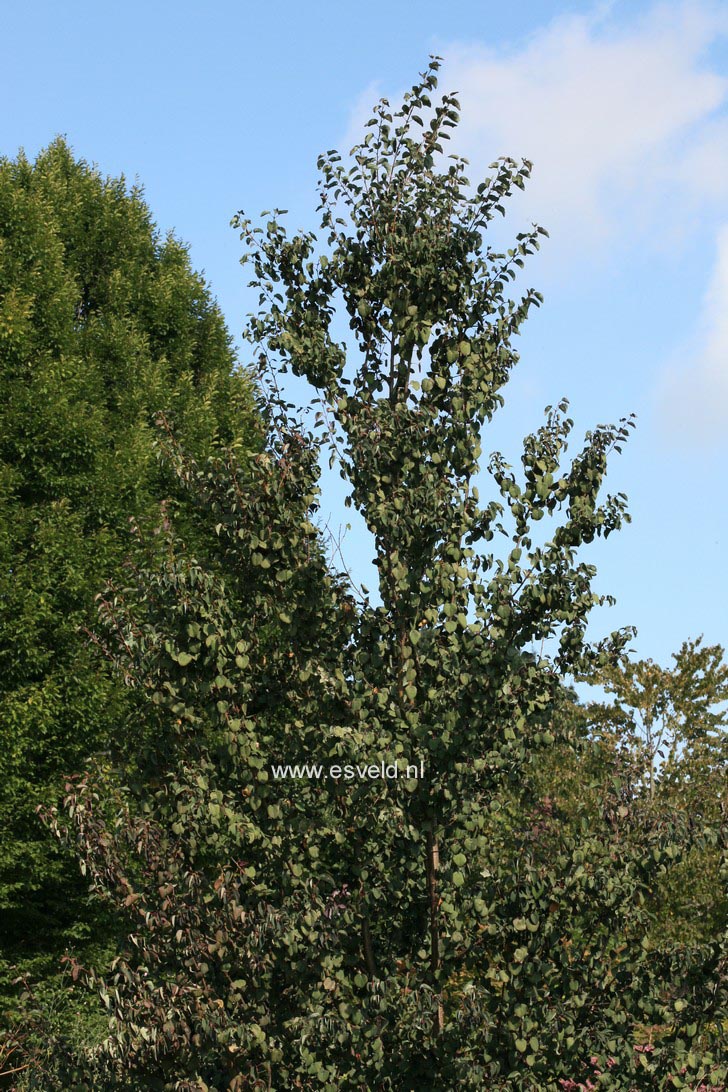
[0,0,728,662]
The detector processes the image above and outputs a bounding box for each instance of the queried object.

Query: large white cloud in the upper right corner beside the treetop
[441,3,728,246]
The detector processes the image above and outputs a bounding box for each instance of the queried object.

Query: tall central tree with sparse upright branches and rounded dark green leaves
[19,68,725,1092]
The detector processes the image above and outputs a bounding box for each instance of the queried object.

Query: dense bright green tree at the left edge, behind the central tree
[0,140,256,1017]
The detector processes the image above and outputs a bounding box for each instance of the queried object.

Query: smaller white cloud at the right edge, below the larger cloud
[657,224,728,448]
